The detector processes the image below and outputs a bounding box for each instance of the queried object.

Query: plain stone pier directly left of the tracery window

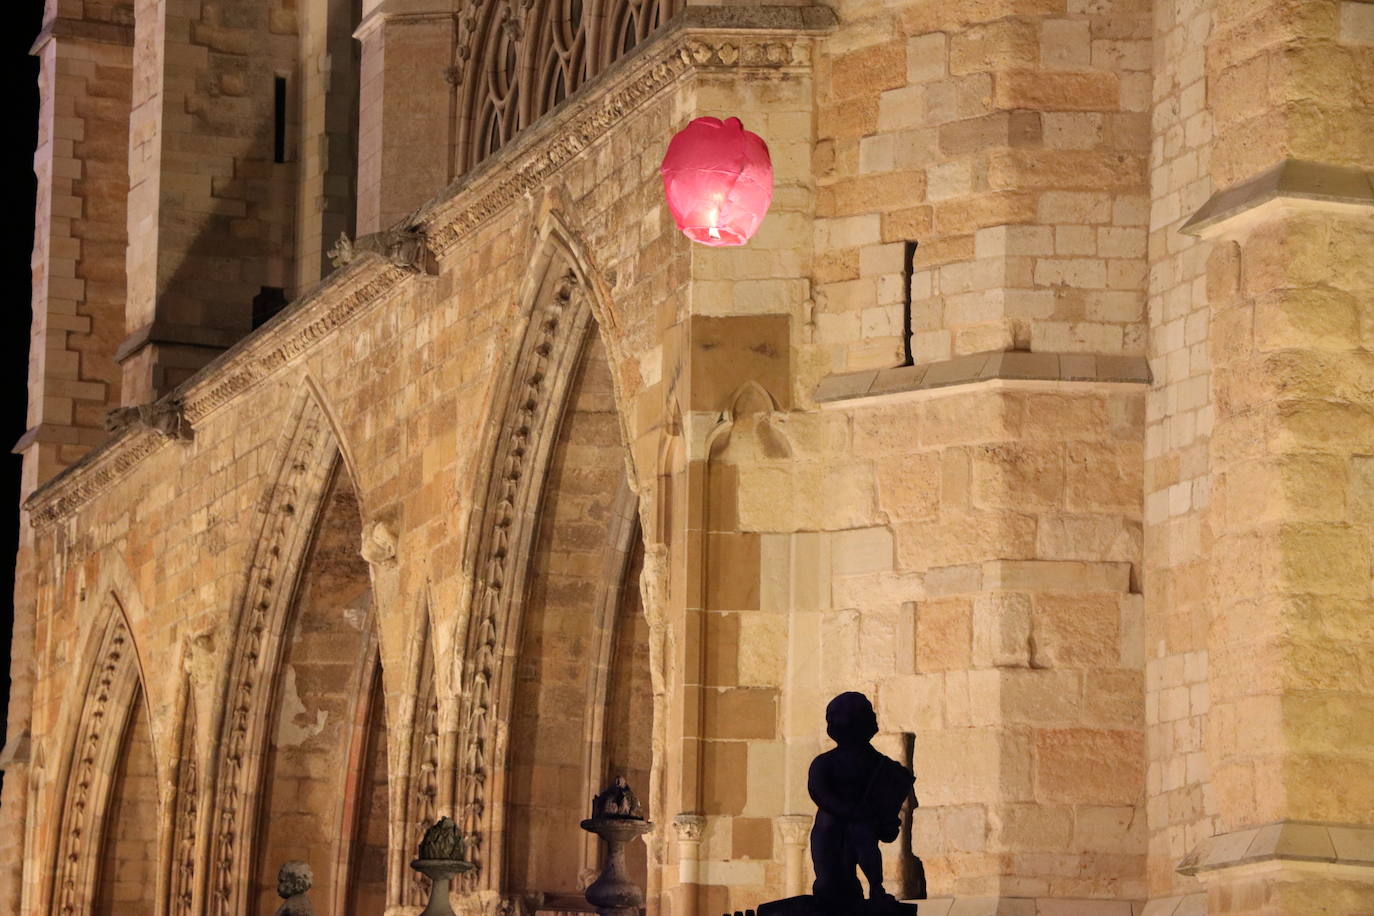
[354,0,453,235]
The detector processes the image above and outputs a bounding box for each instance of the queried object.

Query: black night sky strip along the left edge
[0,0,43,758]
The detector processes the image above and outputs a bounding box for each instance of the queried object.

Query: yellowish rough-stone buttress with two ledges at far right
[1180,0,1374,915]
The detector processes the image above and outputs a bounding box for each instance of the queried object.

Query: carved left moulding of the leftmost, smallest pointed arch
[49,592,155,916]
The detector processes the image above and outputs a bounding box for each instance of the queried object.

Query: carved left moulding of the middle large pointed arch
[201,387,339,916]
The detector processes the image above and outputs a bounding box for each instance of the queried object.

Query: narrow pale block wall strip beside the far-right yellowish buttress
[1145,0,1216,902]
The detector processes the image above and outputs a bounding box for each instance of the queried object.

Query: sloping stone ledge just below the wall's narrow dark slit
[815,350,1150,404]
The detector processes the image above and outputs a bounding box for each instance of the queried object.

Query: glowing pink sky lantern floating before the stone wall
[662,118,772,246]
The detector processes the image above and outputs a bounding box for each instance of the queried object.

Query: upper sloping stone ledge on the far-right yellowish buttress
[1179,159,1374,239]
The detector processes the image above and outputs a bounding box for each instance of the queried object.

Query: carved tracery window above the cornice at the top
[452,0,686,174]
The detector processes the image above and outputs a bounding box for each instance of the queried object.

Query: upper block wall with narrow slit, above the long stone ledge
[815,0,1151,371]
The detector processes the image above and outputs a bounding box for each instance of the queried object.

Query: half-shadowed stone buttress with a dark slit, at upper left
[118,0,301,404]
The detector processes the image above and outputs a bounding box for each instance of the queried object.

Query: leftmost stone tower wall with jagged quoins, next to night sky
[16,5,132,492]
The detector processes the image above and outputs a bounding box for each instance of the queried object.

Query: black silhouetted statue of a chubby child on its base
[758,692,916,916]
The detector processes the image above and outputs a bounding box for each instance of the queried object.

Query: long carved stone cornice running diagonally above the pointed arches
[23,5,835,529]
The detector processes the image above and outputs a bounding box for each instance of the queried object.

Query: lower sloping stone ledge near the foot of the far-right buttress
[1178,821,1374,875]
